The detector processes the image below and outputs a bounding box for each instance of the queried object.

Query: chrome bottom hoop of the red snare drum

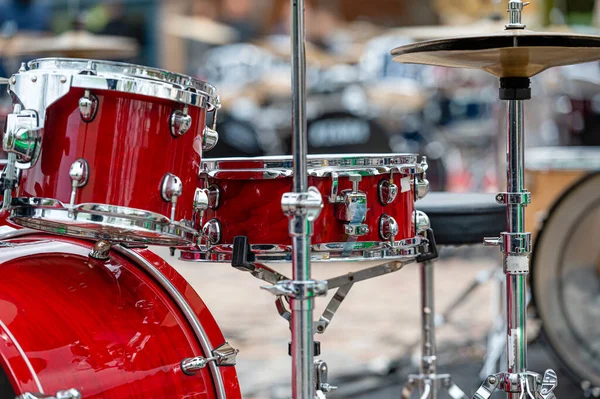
[179,236,429,263]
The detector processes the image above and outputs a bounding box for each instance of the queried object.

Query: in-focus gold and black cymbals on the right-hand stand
[392,29,600,78]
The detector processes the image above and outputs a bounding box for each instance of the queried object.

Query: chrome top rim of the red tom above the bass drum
[10,57,220,110]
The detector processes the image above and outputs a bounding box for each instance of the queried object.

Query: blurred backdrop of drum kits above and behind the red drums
[0,0,600,195]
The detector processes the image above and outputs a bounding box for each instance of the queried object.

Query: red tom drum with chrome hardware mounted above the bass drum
[4,58,218,246]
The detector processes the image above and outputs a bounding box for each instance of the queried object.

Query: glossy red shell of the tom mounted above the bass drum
[18,89,206,220]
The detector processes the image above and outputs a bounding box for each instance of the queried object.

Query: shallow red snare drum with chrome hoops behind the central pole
[182,154,428,262]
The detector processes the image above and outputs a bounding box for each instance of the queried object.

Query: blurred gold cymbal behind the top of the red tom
[11,30,138,60]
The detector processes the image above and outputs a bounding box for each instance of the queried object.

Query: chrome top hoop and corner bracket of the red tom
[9,58,220,120]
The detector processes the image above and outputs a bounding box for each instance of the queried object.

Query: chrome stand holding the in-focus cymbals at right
[473,0,558,399]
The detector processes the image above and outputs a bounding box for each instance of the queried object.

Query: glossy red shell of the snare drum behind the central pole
[200,174,415,245]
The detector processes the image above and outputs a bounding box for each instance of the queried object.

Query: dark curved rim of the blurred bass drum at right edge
[530,171,600,383]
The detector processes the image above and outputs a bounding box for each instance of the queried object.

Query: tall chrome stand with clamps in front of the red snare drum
[262,0,327,399]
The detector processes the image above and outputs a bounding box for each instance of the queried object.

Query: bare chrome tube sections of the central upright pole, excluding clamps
[290,0,315,399]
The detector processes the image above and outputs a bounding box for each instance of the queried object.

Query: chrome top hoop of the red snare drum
[200,154,425,180]
